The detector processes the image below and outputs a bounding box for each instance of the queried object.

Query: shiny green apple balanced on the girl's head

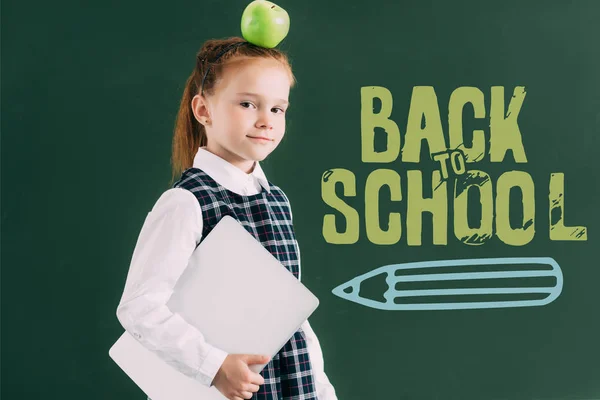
[242,0,290,49]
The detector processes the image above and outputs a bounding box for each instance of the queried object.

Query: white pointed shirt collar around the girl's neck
[193,147,271,193]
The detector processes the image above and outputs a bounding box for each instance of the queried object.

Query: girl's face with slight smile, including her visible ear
[192,58,290,173]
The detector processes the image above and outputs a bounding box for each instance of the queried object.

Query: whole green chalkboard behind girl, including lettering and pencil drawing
[1,0,600,400]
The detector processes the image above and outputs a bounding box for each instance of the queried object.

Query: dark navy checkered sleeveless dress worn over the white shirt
[173,168,317,400]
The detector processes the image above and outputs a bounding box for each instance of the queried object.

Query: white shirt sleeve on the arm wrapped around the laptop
[117,188,227,386]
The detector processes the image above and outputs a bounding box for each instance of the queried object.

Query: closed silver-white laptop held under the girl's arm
[109,216,319,400]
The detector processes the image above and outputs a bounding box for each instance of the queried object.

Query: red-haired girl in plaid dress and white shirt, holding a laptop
[117,37,336,400]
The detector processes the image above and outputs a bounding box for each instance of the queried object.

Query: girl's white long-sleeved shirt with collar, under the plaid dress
[117,148,337,400]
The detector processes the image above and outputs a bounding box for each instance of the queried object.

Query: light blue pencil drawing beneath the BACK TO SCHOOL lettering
[332,257,563,310]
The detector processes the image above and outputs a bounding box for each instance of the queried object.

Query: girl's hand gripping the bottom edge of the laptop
[213,354,270,400]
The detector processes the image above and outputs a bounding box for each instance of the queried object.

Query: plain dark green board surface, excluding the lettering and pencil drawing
[1,0,600,400]
